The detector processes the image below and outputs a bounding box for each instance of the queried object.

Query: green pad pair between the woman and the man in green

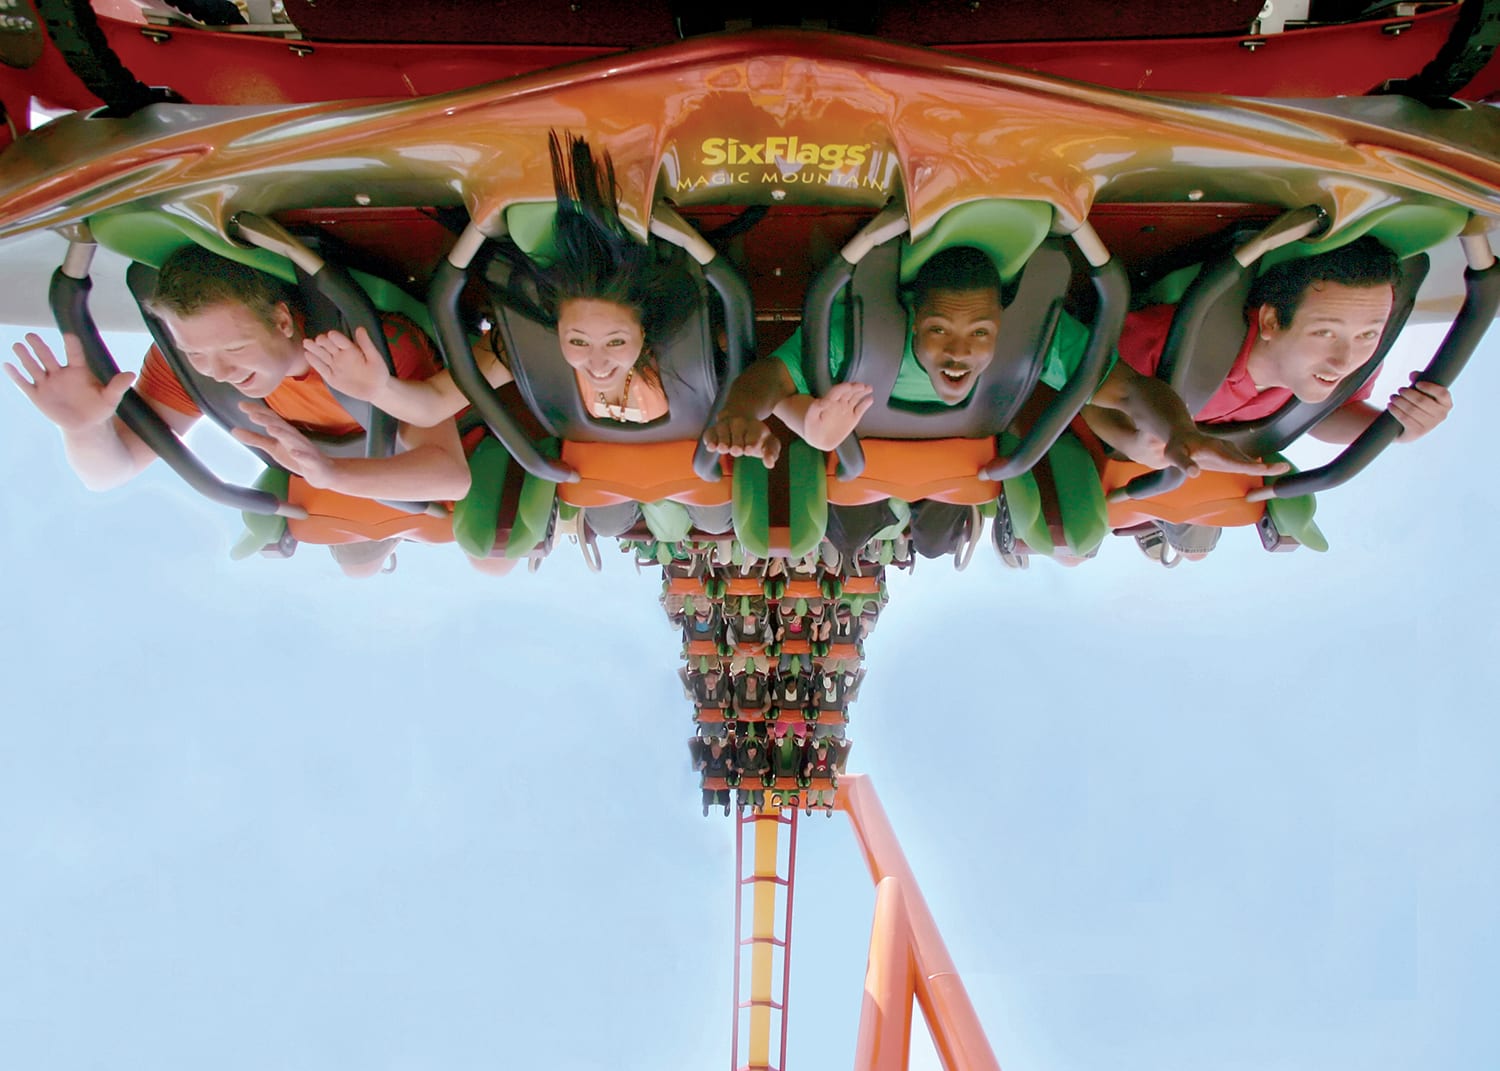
[732,440,828,558]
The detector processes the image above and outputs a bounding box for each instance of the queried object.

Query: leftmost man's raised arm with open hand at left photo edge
[5,333,197,491]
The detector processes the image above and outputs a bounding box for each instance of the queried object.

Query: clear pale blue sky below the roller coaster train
[0,310,1500,1071]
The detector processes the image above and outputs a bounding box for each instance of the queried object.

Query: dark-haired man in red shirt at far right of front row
[1085,237,1454,468]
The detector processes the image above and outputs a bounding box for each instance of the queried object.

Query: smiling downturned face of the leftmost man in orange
[159,302,308,398]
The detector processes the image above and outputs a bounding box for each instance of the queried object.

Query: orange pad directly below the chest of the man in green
[828,438,1001,506]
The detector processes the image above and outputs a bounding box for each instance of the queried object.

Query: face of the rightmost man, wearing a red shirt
[1247,282,1395,402]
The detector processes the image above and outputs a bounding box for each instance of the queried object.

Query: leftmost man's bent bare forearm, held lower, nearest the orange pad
[234,404,470,501]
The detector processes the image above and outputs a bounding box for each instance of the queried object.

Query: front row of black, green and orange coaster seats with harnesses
[60,201,1494,573]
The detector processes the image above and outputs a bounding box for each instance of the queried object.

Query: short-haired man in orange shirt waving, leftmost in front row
[6,246,470,564]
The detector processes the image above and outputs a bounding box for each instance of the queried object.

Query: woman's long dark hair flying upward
[531,131,696,362]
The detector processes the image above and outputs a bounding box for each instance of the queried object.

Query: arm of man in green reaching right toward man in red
[1083,362,1289,476]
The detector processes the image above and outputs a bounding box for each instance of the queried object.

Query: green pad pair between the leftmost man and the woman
[453,437,557,558]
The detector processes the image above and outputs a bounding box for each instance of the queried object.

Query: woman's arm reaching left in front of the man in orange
[303,327,512,428]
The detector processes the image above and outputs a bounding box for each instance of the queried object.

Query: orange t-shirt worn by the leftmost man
[135,312,443,435]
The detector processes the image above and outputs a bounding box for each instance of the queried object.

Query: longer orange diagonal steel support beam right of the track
[836,774,1001,1071]
